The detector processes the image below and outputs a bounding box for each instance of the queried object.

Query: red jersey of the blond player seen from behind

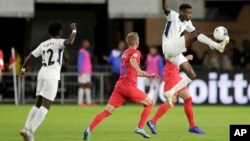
[117,48,141,85]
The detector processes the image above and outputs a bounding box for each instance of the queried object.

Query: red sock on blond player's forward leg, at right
[138,103,153,128]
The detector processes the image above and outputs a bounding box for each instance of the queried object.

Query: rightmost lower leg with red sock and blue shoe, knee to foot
[179,89,205,134]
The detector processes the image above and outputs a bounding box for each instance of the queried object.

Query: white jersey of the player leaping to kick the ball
[163,10,195,40]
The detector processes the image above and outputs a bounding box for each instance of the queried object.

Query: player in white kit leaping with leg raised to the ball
[162,0,229,107]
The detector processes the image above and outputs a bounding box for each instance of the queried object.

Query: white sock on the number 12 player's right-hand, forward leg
[30,106,48,133]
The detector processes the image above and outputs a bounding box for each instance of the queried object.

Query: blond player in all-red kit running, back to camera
[83,32,158,141]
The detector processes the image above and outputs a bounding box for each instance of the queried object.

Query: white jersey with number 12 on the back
[31,38,65,80]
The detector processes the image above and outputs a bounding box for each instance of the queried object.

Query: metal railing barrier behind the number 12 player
[0,72,111,104]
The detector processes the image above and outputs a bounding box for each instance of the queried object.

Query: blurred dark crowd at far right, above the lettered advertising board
[202,39,250,71]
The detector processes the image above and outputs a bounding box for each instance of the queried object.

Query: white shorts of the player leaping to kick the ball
[162,36,188,67]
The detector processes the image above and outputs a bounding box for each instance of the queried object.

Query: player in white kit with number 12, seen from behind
[20,21,76,141]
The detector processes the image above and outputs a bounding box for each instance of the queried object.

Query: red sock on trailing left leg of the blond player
[89,110,111,132]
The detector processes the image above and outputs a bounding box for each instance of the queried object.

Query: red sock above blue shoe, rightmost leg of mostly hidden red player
[184,97,196,127]
